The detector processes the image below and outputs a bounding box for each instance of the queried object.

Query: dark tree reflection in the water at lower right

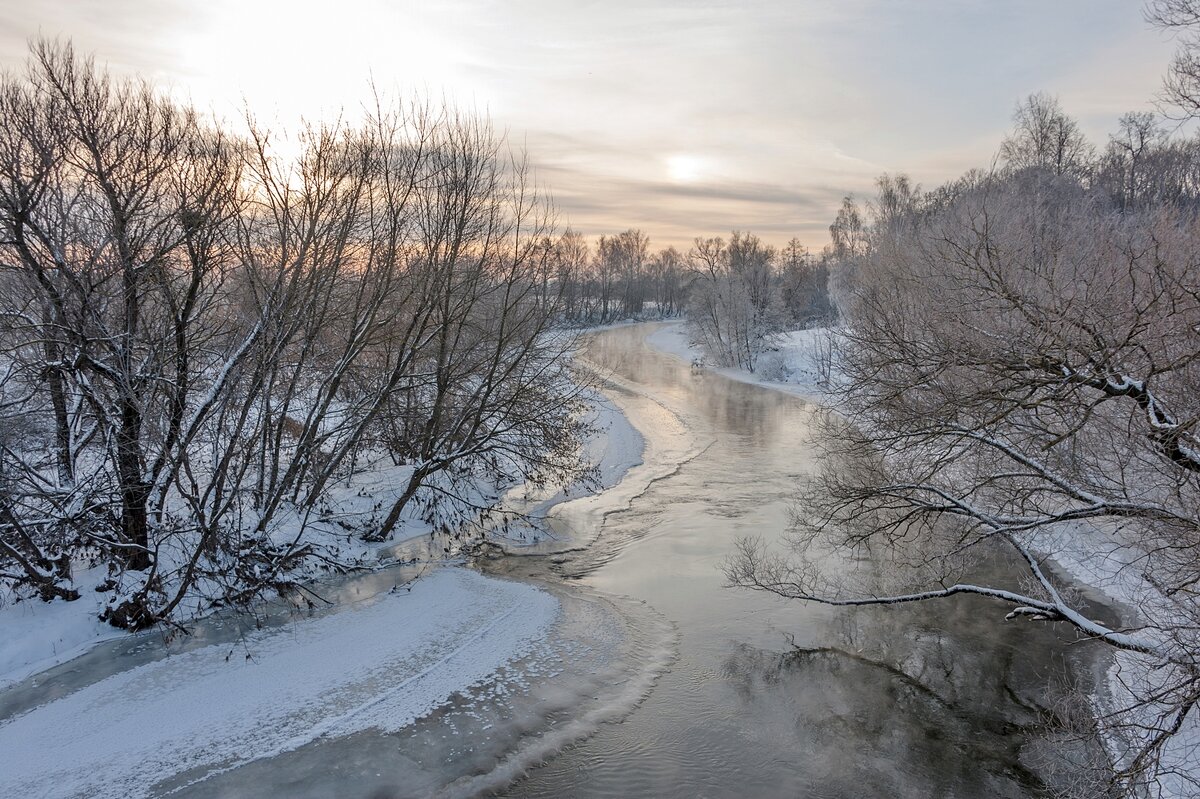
[722,613,1104,797]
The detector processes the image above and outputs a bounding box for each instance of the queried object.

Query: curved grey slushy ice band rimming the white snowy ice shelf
[163,585,677,799]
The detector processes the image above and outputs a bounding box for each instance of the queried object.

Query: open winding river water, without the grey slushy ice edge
[487,326,1091,798]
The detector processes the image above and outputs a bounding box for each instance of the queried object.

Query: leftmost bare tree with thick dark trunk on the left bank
[0,42,255,611]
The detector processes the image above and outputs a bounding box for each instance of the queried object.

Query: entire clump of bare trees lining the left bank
[0,42,597,627]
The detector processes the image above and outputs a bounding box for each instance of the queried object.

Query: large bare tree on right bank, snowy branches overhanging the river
[728,173,1200,792]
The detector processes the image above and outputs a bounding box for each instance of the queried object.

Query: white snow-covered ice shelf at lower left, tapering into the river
[0,569,559,797]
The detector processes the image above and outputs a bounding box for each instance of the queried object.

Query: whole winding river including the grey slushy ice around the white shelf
[0,325,1093,799]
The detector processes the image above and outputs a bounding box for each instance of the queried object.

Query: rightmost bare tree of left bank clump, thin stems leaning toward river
[364,118,587,536]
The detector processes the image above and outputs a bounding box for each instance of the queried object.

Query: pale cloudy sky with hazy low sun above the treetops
[0,0,1175,248]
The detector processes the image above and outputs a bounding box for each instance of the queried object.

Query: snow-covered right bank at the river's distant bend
[646,322,832,403]
